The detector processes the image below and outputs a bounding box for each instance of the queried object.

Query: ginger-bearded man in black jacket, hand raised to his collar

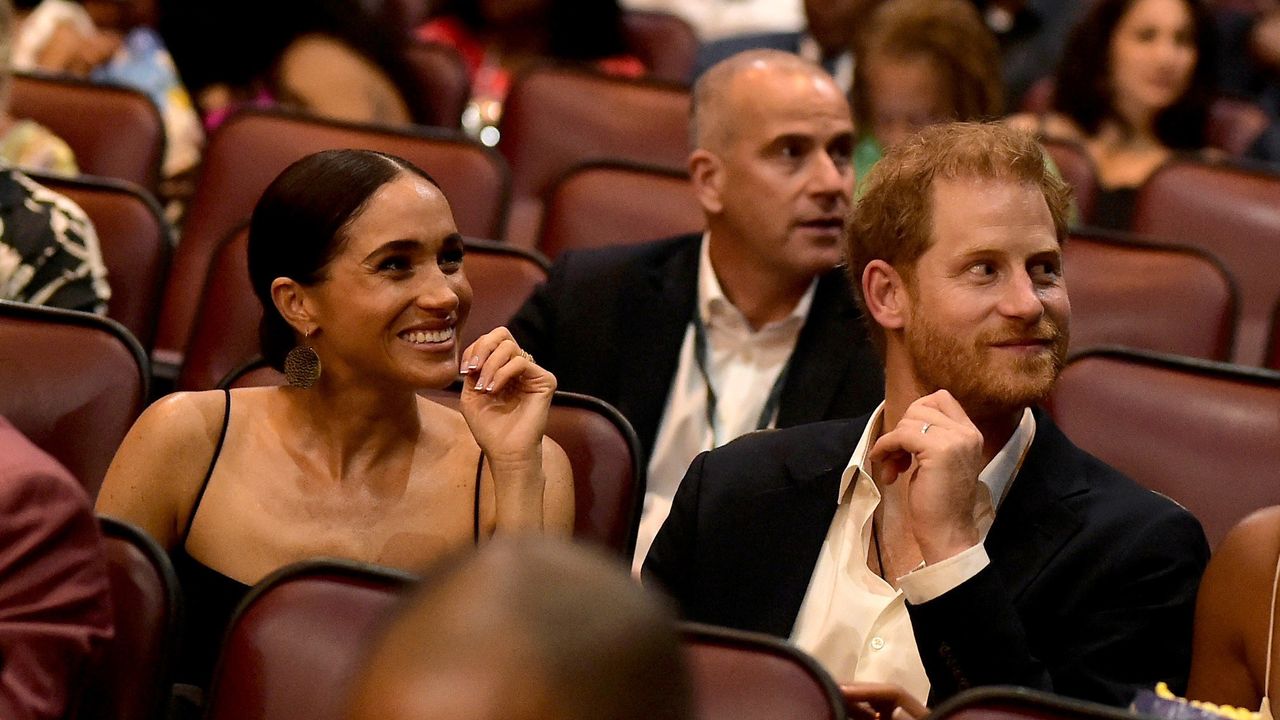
[644,123,1208,705]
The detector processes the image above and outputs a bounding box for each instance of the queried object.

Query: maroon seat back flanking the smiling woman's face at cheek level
[178,234,548,389]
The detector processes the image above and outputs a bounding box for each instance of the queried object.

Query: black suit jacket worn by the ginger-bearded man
[644,413,1208,705]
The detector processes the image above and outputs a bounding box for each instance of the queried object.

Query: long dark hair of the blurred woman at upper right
[1053,0,1216,150]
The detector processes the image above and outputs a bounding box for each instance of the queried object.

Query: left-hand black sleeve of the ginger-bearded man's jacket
[641,452,708,604]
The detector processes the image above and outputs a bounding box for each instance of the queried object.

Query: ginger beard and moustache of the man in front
[902,288,1070,420]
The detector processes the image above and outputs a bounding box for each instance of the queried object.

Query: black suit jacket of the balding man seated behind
[509,234,884,455]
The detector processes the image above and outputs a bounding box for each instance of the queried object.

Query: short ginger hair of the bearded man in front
[845,123,1071,356]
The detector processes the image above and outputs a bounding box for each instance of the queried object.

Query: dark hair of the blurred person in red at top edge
[431,0,627,61]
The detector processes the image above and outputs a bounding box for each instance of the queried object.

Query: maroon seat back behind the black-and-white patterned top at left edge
[28,173,173,348]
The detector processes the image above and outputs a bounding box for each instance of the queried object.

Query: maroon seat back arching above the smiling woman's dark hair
[155,110,509,365]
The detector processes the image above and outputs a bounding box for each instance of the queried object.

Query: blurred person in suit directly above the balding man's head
[698,0,883,94]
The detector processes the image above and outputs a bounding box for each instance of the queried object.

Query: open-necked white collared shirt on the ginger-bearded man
[791,404,1036,700]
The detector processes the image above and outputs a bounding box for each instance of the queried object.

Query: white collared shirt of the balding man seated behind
[631,233,818,574]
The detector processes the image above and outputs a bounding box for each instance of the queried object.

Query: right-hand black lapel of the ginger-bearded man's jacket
[986,410,1088,602]
